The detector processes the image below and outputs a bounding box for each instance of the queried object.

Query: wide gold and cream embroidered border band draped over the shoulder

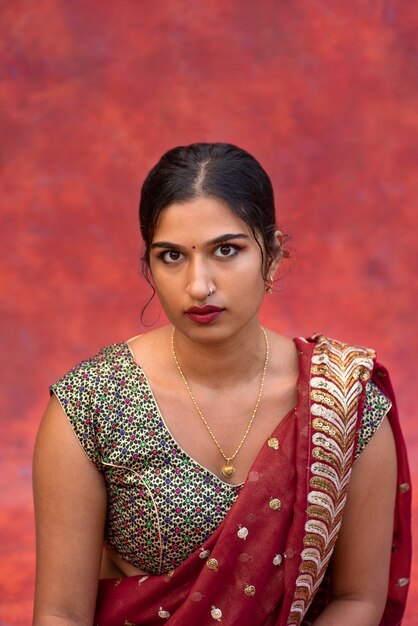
[287,336,376,626]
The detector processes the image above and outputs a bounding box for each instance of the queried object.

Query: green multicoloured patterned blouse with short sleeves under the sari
[51,343,391,574]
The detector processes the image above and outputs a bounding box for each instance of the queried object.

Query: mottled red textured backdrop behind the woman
[0,0,418,626]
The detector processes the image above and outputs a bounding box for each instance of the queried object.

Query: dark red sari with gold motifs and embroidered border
[94,336,411,626]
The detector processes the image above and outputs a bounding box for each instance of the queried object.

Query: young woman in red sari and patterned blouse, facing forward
[34,144,410,626]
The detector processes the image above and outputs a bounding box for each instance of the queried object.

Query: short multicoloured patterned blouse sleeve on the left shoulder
[50,359,102,470]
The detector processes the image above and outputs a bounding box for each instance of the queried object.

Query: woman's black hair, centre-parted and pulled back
[139,143,288,316]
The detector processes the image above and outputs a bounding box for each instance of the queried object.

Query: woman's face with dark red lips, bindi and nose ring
[150,198,276,341]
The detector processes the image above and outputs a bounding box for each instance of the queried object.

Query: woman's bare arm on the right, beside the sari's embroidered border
[314,418,397,626]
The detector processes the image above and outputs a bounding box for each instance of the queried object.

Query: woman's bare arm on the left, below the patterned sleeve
[33,396,106,626]
